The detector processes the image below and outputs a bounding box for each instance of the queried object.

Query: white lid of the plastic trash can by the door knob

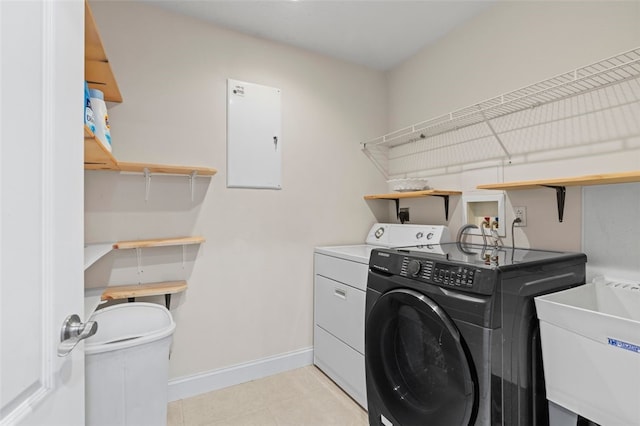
[85,302,176,354]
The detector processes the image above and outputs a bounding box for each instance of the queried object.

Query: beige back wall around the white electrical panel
[86,2,387,378]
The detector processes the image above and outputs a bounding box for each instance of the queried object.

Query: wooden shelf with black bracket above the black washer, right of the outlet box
[477,170,640,222]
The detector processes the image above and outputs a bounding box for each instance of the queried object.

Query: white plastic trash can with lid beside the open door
[85,302,176,426]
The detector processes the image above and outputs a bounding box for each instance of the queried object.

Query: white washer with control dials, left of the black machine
[313,223,450,409]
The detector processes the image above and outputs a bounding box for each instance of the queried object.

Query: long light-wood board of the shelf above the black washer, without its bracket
[477,171,640,190]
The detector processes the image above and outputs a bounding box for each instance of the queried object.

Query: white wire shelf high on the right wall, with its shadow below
[362,48,640,178]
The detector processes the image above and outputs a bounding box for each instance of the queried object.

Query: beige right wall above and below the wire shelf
[384,1,640,250]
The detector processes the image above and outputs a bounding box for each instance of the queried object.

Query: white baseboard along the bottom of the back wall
[169,347,313,402]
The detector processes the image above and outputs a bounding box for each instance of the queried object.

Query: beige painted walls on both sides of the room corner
[85,2,640,378]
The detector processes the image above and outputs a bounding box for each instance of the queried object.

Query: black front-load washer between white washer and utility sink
[365,243,587,426]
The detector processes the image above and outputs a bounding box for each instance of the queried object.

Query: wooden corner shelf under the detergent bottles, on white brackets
[84,126,218,176]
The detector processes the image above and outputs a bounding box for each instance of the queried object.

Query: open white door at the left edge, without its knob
[0,0,84,426]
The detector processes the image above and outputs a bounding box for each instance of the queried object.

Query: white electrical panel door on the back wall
[227,79,282,189]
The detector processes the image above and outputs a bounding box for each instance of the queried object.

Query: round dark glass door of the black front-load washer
[365,289,477,426]
